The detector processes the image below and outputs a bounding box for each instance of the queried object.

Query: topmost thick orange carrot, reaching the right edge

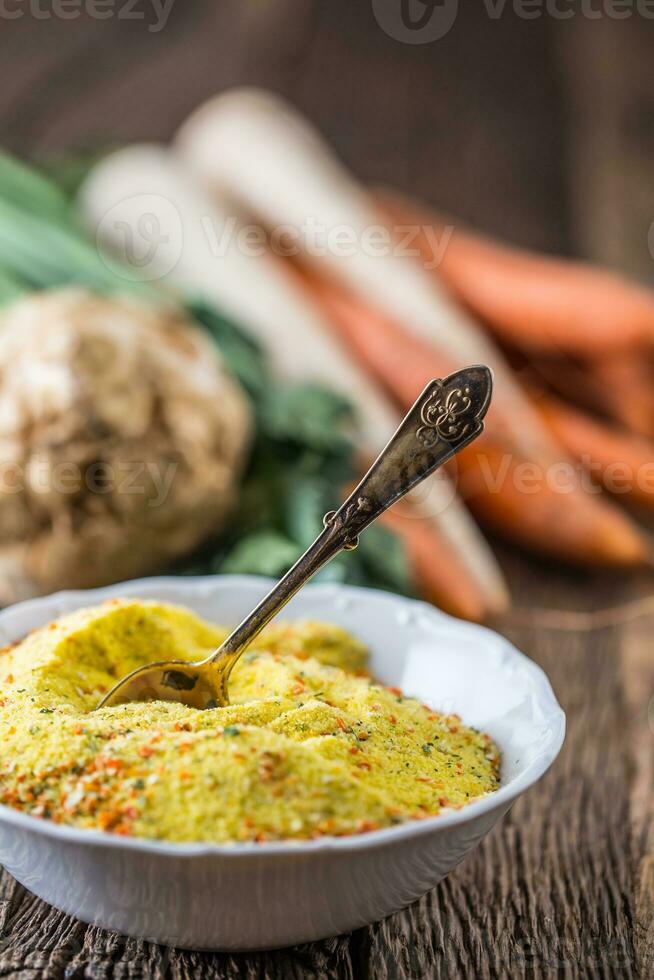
[378,192,654,357]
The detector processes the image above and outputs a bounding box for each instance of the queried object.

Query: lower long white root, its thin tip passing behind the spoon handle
[80,145,508,612]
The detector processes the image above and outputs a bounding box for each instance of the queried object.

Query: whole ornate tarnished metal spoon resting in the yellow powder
[98,366,493,708]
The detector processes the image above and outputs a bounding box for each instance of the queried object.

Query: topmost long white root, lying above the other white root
[176,89,555,464]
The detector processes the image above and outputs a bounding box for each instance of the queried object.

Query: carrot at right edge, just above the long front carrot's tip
[536,396,654,510]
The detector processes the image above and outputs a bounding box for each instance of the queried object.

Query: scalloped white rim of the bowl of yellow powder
[0,575,566,859]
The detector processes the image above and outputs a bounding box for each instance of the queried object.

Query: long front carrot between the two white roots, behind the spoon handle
[312,281,649,566]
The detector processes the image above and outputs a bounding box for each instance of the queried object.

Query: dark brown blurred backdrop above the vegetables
[0,0,654,268]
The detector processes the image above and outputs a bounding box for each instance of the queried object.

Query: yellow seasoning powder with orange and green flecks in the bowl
[0,600,499,842]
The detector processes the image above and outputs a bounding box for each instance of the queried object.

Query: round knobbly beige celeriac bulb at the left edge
[0,289,252,604]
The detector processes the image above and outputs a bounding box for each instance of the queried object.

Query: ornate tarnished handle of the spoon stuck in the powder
[209,366,493,684]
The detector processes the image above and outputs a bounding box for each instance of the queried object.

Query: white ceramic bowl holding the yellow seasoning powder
[0,576,565,950]
